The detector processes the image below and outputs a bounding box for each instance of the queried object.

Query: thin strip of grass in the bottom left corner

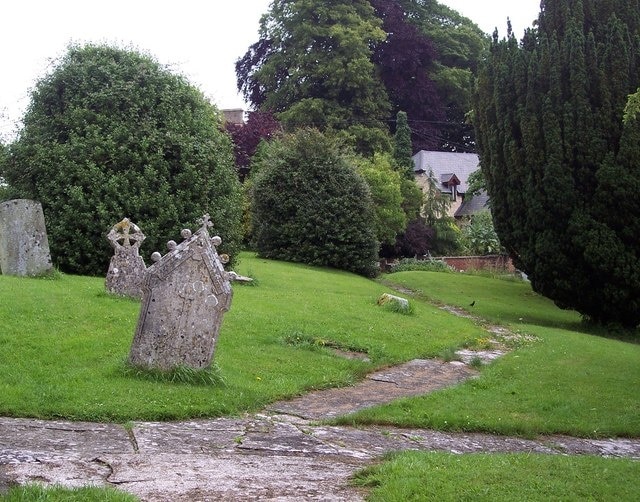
[0,484,139,502]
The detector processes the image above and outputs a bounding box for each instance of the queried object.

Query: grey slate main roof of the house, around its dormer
[412,150,480,193]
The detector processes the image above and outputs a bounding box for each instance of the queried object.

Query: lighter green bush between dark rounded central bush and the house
[354,154,407,244]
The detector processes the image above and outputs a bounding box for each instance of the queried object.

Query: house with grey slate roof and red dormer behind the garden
[412,150,489,219]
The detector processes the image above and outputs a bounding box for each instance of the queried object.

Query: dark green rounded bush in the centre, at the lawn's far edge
[252,129,378,276]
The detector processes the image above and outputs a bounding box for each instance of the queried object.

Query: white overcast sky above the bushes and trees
[0,0,540,138]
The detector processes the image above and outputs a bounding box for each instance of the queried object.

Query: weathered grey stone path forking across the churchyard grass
[0,300,640,502]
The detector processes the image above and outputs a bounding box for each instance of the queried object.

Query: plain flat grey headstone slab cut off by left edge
[0,199,52,276]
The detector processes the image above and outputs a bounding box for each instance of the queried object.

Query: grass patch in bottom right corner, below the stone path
[354,452,640,502]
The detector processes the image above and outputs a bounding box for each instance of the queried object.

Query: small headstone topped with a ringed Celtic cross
[105,218,147,298]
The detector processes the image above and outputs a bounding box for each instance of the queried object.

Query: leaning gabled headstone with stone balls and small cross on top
[129,215,232,370]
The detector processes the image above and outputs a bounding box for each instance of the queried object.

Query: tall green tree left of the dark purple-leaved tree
[236,0,389,153]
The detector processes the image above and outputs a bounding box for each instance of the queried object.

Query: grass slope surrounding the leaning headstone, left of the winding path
[0,254,482,422]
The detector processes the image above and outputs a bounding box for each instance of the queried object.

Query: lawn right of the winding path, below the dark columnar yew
[338,272,640,437]
